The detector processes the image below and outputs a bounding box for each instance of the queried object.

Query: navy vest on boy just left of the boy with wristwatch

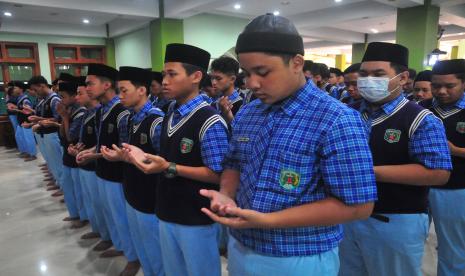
[123,114,163,214]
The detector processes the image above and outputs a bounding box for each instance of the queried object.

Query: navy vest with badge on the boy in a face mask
[351,99,430,214]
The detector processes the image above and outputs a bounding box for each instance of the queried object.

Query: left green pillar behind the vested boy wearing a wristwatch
[150,18,184,71]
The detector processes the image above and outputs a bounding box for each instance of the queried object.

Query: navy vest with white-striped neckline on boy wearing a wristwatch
[155,104,220,225]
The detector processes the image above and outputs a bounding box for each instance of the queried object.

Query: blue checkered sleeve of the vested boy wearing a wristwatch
[200,118,228,173]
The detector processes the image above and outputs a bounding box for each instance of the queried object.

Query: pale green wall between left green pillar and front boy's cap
[184,14,249,58]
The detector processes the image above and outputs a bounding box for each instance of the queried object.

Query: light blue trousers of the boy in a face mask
[339,214,428,276]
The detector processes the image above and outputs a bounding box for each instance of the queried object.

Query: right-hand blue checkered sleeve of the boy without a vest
[321,109,377,204]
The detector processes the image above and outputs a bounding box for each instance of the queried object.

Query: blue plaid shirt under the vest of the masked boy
[360,94,452,171]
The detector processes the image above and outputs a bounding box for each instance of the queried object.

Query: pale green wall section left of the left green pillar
[114,26,152,68]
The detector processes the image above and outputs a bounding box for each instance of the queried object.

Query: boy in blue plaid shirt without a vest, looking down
[201,14,376,276]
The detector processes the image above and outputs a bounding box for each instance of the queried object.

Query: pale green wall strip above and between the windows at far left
[0,33,105,82]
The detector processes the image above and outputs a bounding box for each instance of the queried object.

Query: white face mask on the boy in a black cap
[357,74,400,103]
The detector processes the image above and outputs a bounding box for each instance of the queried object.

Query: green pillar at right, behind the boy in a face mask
[396,0,439,71]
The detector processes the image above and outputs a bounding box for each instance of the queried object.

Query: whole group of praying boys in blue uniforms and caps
[13,11,465,276]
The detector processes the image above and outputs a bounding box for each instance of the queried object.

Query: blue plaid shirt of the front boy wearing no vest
[224,80,377,256]
